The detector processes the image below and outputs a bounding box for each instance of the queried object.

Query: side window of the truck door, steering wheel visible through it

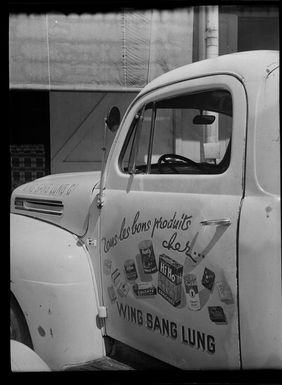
[120,90,232,174]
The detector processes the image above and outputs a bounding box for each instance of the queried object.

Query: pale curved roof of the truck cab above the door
[138,50,279,97]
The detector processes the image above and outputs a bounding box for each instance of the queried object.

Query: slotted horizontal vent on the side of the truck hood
[15,197,64,215]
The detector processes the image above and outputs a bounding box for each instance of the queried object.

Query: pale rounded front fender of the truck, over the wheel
[11,214,105,370]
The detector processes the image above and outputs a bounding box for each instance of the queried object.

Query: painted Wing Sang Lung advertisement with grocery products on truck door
[101,200,238,368]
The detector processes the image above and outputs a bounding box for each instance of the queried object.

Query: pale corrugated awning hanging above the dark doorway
[9,7,193,91]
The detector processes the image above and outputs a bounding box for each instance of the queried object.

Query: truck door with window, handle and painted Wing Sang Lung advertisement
[101,74,246,369]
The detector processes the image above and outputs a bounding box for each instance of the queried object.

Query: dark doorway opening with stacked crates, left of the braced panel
[9,90,50,190]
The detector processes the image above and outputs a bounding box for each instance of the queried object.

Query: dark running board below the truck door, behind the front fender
[64,356,135,371]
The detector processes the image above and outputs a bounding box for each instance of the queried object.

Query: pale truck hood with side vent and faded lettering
[11,171,101,236]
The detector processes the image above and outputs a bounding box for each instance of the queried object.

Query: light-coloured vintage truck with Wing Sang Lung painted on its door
[10,51,282,370]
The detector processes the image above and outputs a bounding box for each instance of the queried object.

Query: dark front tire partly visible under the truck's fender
[10,297,33,349]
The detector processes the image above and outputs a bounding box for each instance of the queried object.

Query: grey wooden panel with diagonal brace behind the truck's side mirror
[50,91,137,174]
